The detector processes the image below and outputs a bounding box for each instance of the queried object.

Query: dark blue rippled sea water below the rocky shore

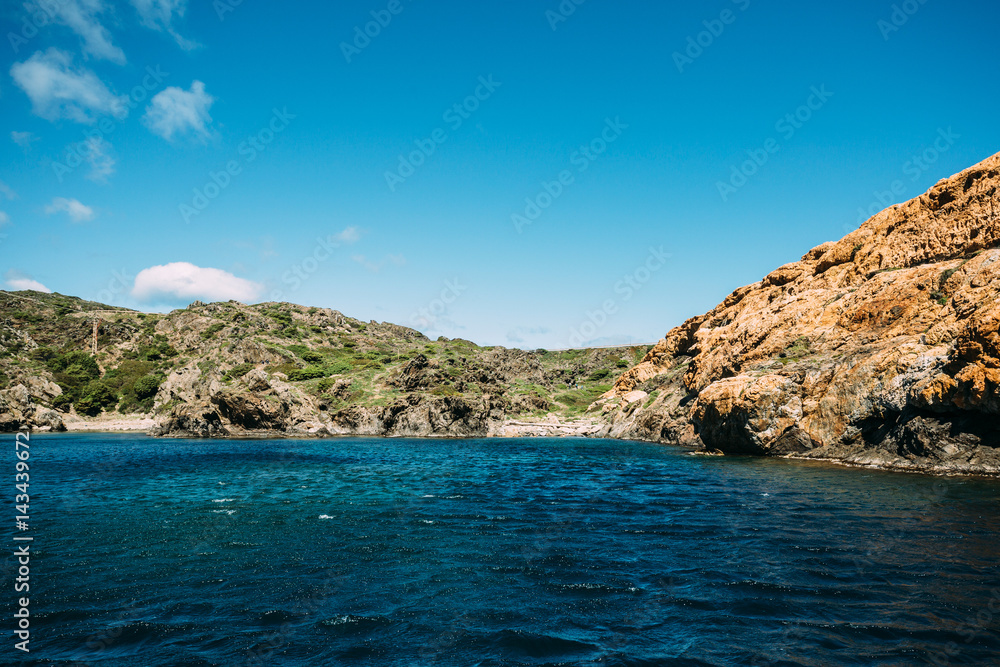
[7,434,1000,667]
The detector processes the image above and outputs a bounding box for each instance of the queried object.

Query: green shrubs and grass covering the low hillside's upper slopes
[0,297,664,422]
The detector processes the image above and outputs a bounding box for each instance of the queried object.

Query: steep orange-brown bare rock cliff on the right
[596,155,1000,474]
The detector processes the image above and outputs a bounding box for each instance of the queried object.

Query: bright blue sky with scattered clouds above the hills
[0,0,1000,349]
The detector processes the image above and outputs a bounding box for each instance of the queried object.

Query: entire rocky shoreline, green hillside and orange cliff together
[0,151,1000,474]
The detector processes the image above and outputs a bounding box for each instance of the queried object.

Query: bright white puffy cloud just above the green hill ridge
[132,262,264,303]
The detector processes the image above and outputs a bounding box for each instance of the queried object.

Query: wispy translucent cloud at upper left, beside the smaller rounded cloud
[10,48,128,123]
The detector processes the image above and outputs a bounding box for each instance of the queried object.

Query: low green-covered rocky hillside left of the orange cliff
[0,292,650,444]
